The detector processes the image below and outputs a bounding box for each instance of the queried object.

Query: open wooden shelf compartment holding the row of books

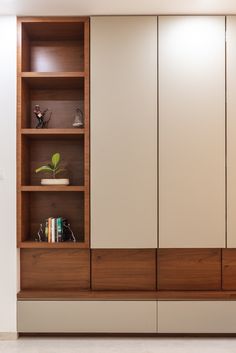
[18,191,85,243]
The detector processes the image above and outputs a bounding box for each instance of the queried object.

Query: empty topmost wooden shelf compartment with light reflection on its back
[21,20,84,72]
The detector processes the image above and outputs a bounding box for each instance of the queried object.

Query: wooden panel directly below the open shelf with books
[21,249,90,290]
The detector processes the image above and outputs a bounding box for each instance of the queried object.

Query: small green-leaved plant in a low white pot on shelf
[35,152,70,185]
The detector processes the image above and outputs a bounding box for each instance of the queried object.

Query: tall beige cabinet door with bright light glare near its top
[159,16,225,248]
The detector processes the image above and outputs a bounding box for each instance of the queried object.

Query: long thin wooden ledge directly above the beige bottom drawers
[17,290,236,300]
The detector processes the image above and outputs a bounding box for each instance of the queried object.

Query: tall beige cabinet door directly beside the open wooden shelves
[91,16,157,248]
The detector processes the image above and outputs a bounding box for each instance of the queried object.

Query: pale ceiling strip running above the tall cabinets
[0,0,236,16]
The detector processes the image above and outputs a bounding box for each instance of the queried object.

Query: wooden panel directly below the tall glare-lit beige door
[157,249,221,290]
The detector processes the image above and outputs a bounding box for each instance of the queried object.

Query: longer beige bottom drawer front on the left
[18,301,156,333]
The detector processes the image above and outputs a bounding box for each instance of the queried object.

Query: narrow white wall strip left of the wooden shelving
[0,16,16,332]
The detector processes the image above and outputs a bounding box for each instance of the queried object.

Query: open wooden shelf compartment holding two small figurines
[21,77,84,131]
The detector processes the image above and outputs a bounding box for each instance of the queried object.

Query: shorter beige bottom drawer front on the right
[157,301,236,333]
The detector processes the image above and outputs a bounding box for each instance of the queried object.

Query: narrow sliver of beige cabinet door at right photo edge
[227,16,236,248]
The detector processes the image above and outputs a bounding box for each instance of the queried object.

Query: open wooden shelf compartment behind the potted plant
[21,135,84,186]
